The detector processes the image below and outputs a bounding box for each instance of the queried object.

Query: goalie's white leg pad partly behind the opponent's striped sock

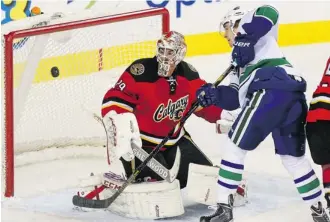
[187,163,247,207]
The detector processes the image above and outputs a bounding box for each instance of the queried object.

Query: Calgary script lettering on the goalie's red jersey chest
[153,95,189,122]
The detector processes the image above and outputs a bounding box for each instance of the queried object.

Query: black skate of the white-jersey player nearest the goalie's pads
[200,194,234,222]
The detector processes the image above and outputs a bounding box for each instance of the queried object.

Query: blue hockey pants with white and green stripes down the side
[228,89,307,157]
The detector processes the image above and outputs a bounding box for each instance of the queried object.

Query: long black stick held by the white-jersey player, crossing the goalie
[72,64,236,208]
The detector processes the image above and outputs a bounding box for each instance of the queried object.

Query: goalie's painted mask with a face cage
[156,31,187,77]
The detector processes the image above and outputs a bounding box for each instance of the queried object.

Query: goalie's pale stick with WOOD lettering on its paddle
[82,106,181,183]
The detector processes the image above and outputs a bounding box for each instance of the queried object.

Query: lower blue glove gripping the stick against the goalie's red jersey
[196,83,217,107]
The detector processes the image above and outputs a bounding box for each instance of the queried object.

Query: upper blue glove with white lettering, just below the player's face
[232,33,258,68]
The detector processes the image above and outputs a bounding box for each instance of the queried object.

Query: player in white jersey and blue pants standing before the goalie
[197,5,329,222]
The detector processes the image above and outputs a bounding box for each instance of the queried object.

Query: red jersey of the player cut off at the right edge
[307,58,330,122]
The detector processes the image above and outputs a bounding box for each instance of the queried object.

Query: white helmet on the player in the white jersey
[220,6,247,36]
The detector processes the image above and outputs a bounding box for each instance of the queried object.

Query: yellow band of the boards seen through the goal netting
[14,41,156,86]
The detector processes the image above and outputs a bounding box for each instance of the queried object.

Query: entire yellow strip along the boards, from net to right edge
[14,21,330,85]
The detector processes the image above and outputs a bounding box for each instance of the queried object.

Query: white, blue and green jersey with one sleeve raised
[238,5,306,106]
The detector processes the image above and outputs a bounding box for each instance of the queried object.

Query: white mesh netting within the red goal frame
[1,8,162,154]
